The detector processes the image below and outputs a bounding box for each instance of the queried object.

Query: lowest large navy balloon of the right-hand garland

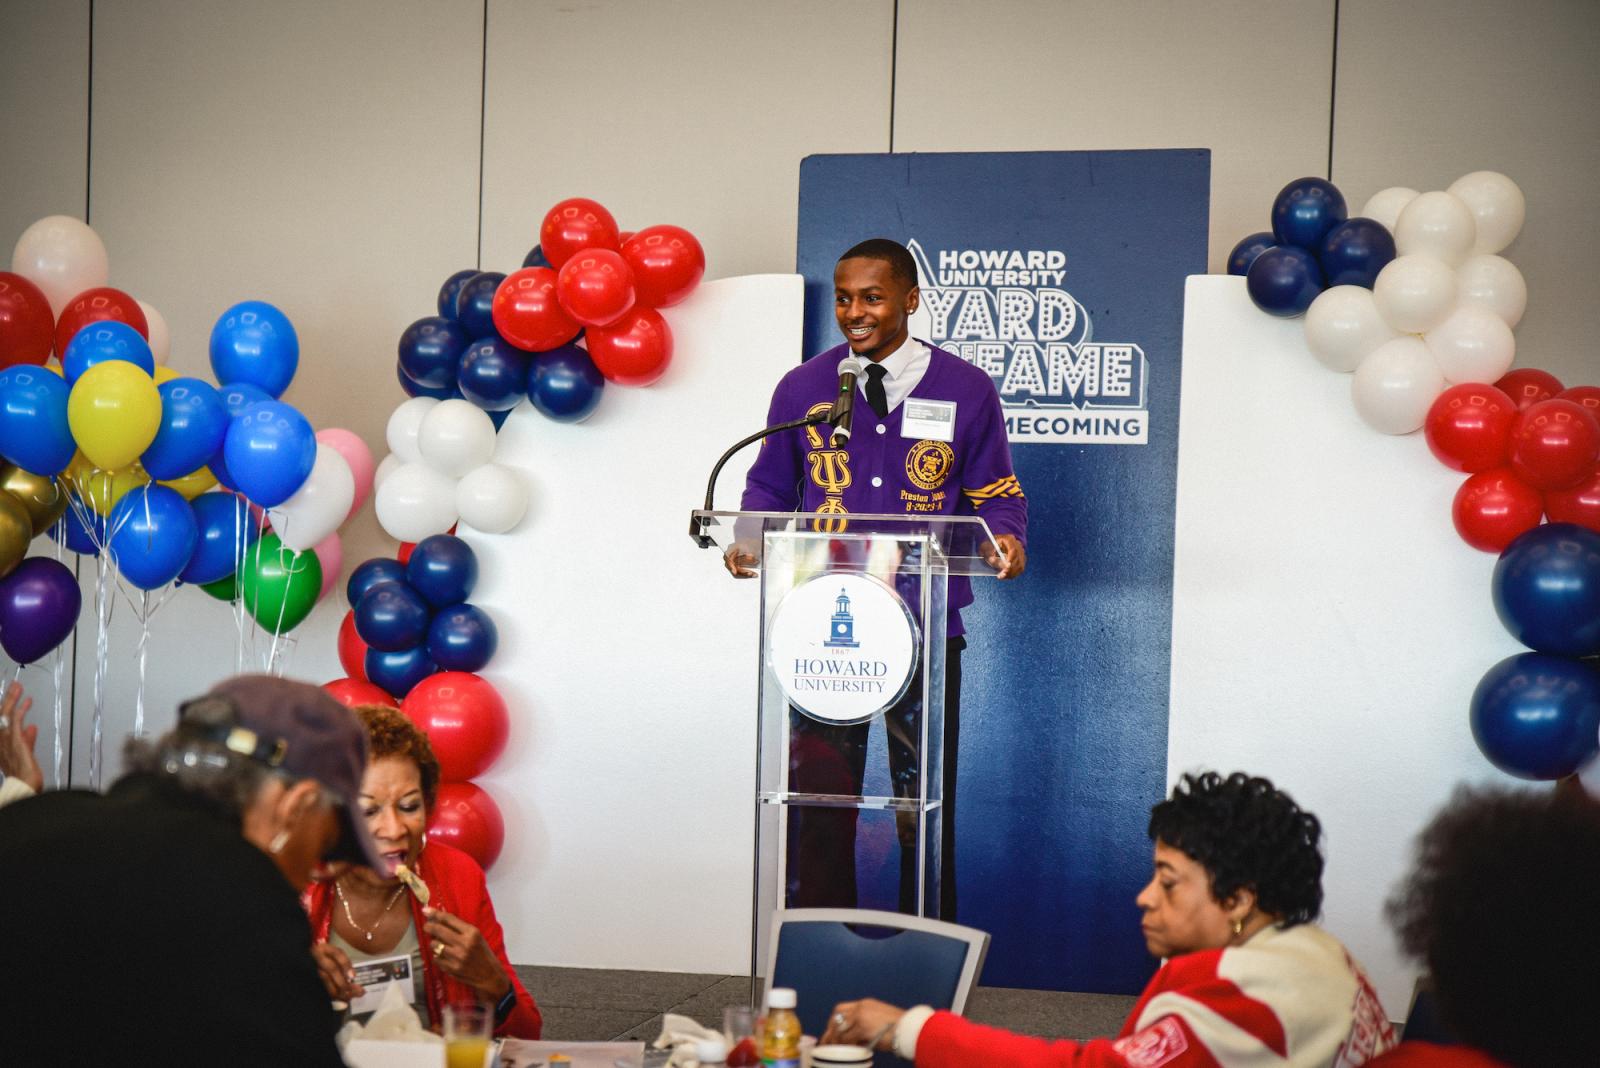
[1472,652,1600,780]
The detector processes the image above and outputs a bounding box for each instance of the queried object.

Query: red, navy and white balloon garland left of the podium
[325,198,706,868]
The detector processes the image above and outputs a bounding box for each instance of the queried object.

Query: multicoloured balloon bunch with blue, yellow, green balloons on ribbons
[0,216,373,787]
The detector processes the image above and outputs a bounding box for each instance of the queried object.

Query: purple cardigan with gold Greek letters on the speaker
[739,342,1027,638]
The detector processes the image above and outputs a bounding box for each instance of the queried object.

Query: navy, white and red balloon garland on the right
[1229,171,1600,780]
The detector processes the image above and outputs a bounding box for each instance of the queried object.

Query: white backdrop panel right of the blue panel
[1168,277,1522,1015]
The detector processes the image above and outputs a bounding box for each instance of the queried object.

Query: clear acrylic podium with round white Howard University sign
[694,510,1000,977]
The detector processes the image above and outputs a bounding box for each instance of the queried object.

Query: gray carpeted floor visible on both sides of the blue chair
[517,966,1134,1042]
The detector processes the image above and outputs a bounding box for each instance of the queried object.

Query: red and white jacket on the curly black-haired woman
[896,924,1395,1068]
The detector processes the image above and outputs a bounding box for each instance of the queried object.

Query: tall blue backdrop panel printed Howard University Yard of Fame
[798,149,1210,993]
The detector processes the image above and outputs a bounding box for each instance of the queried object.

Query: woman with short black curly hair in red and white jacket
[822,772,1394,1068]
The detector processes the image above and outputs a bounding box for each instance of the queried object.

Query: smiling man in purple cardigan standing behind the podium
[723,238,1027,921]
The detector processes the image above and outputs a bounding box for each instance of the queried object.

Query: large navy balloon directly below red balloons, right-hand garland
[1493,523,1600,657]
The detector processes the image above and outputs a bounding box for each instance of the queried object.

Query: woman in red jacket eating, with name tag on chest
[304,705,541,1039]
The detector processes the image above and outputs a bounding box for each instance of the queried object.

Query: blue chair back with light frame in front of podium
[763,908,989,1036]
